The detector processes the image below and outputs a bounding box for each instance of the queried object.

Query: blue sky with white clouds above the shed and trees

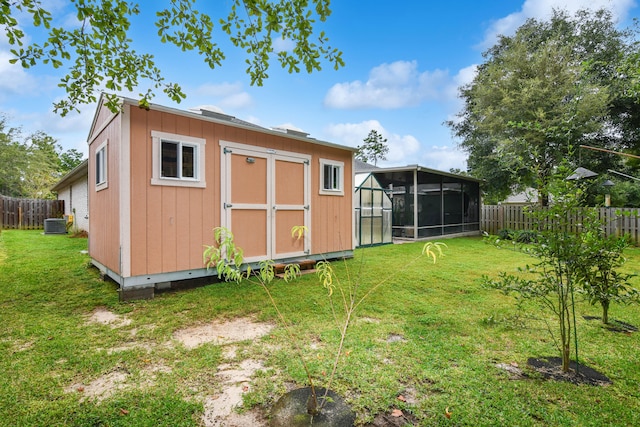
[0,0,640,171]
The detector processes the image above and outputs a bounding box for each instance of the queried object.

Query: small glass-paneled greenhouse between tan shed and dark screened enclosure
[354,173,393,246]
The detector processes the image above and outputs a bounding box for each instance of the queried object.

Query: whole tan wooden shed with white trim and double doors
[88,94,355,299]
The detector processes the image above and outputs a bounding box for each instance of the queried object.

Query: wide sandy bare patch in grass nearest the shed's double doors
[173,318,273,349]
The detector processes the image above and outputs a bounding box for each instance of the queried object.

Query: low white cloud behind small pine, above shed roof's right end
[324,120,420,166]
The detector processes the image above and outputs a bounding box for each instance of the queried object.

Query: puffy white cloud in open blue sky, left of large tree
[324,61,450,109]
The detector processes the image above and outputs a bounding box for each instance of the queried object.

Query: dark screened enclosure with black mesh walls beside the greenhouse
[358,165,480,239]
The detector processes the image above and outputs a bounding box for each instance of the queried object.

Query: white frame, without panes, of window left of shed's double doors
[151,130,207,188]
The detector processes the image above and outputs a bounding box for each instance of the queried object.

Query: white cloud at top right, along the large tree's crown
[480,0,636,49]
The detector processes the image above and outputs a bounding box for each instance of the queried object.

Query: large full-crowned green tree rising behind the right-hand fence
[447,10,629,203]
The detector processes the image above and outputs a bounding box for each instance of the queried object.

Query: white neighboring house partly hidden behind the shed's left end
[51,160,89,231]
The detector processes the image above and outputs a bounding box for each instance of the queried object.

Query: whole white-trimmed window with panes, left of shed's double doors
[151,131,206,187]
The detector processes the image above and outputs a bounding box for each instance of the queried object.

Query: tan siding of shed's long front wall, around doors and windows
[122,107,352,276]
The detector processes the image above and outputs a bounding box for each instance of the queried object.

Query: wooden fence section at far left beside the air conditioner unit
[0,195,64,229]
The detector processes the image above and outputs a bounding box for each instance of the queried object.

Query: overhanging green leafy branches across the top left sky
[0,0,344,115]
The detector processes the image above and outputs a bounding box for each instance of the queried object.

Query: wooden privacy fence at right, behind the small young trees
[480,205,640,245]
